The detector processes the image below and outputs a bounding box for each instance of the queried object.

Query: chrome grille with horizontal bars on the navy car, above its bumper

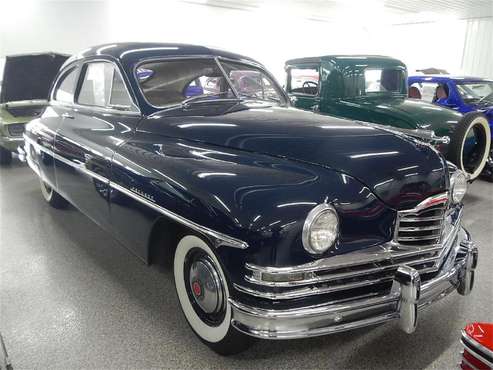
[240,193,456,300]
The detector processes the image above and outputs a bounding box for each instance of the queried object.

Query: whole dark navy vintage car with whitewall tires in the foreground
[25,43,477,354]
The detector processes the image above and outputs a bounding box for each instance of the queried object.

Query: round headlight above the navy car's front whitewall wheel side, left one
[302,204,339,254]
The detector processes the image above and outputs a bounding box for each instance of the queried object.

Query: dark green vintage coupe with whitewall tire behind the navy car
[285,55,491,180]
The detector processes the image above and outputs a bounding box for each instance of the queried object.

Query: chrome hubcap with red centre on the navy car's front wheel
[189,256,224,314]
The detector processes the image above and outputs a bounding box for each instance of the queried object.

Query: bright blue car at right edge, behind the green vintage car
[408,75,493,181]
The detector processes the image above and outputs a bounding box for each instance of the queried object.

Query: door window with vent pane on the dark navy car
[77,62,132,110]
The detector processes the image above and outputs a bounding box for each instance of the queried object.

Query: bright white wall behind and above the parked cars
[0,0,493,80]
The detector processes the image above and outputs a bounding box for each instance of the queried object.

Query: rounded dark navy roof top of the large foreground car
[67,42,260,65]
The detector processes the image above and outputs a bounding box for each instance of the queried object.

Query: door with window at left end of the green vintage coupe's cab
[286,64,320,112]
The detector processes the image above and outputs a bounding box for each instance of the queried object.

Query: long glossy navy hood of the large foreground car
[139,104,447,209]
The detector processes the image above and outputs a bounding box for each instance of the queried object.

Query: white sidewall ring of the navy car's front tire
[173,235,232,344]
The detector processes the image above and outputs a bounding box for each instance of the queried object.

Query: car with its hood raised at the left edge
[0,53,68,165]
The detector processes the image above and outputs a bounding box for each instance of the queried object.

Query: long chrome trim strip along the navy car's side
[24,135,248,249]
